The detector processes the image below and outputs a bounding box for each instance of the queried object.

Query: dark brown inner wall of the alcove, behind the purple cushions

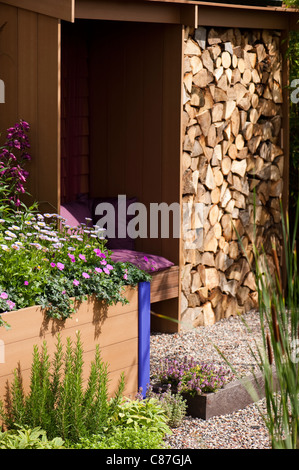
[86,22,182,263]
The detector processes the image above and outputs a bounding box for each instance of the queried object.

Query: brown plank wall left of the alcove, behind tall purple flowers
[0,3,60,211]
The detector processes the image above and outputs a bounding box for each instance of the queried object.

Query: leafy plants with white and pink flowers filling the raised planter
[0,211,150,319]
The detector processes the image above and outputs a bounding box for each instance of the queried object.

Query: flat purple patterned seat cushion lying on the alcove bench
[111,250,174,273]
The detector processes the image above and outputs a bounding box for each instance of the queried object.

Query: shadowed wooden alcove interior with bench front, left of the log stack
[61,20,182,329]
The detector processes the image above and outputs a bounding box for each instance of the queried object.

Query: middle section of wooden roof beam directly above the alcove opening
[75,0,181,24]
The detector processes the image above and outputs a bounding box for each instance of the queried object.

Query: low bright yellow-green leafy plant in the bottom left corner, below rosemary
[0,426,64,449]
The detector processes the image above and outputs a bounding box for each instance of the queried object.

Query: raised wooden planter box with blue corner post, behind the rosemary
[0,283,150,398]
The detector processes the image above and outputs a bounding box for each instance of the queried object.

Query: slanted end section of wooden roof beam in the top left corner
[1,0,75,22]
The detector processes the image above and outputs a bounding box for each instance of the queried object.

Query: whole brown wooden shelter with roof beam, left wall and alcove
[0,0,298,331]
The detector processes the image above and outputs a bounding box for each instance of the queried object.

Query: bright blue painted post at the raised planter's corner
[138,282,151,398]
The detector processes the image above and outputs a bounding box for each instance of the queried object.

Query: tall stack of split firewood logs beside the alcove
[181,27,284,327]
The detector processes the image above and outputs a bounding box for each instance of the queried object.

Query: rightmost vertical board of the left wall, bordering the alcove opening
[37,15,60,211]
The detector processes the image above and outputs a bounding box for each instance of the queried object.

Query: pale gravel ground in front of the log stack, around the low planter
[151,312,271,449]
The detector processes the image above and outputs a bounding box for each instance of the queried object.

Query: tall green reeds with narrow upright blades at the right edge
[217,199,299,449]
